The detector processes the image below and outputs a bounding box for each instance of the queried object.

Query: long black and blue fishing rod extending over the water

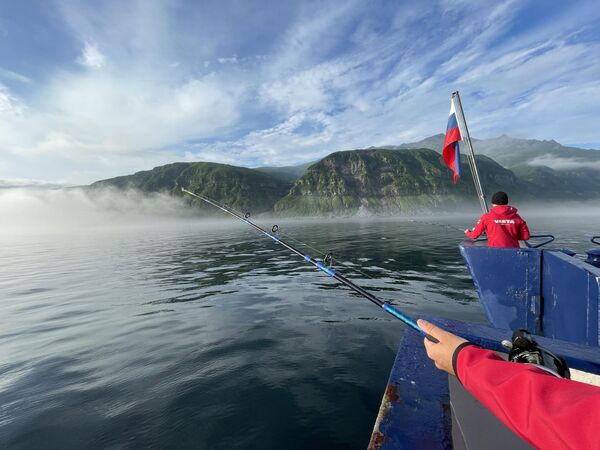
[181,188,439,344]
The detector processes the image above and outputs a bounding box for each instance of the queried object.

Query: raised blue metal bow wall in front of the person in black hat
[460,241,600,346]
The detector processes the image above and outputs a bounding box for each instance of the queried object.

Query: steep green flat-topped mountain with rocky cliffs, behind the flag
[275,148,532,215]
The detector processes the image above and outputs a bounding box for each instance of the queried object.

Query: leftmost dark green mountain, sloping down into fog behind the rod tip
[90,162,290,213]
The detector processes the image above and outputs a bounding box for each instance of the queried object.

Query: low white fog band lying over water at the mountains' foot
[0,187,600,234]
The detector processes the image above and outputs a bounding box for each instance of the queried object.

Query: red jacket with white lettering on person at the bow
[465,205,529,248]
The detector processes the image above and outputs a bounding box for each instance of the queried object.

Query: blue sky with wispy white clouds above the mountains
[0,0,600,184]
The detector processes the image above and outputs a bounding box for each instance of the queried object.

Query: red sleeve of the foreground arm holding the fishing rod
[456,346,600,449]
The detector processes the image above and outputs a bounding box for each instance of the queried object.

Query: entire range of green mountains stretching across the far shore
[90,134,600,216]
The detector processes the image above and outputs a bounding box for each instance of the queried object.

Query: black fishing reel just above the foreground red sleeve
[502,329,571,379]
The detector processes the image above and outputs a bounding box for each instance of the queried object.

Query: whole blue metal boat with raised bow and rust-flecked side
[369,235,600,450]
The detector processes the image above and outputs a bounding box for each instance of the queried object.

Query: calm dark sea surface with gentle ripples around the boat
[0,217,600,449]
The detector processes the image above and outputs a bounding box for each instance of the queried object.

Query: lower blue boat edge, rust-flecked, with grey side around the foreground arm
[369,319,600,450]
